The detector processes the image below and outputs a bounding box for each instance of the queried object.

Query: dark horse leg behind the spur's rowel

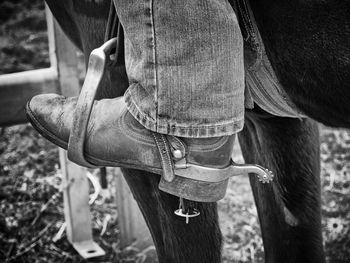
[239,113,325,263]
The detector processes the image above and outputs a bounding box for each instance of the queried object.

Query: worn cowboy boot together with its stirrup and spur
[26,38,272,202]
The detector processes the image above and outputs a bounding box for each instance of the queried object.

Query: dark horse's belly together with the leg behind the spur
[239,0,350,262]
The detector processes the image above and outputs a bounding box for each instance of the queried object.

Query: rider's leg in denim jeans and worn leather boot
[27,0,244,201]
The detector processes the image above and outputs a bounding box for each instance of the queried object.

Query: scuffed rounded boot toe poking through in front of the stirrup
[26,94,77,149]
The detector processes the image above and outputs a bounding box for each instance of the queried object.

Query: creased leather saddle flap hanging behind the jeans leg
[229,0,305,118]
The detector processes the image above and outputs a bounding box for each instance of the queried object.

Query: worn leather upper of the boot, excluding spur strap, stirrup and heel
[26,94,235,177]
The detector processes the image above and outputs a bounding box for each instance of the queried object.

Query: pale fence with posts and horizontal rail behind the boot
[0,7,152,258]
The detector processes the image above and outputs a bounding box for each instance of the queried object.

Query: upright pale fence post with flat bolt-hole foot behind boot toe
[46,7,105,258]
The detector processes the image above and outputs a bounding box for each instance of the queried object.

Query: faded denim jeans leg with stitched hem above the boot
[114,0,244,138]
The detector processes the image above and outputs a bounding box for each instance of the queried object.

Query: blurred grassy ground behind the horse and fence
[0,0,350,263]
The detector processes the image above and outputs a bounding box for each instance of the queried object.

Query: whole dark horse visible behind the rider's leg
[46,0,350,263]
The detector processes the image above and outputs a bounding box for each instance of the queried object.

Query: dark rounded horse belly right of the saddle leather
[251,0,350,128]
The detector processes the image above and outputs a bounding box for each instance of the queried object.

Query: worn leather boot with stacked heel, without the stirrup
[26,94,235,202]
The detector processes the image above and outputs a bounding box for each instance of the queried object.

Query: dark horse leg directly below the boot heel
[122,169,222,263]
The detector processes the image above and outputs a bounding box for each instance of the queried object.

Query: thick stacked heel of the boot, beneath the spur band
[159,176,228,202]
